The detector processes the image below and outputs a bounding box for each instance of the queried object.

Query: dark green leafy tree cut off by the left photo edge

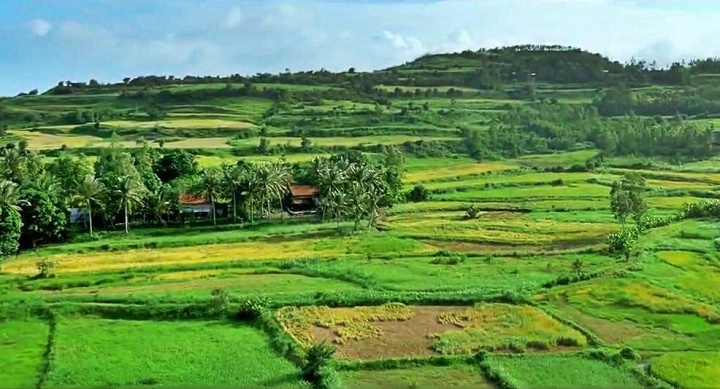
[0,180,22,256]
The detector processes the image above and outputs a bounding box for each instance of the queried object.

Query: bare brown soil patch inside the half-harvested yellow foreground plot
[313,306,466,359]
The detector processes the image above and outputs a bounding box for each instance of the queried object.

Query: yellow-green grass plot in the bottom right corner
[650,352,720,388]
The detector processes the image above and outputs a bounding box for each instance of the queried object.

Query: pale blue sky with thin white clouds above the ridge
[0,0,720,96]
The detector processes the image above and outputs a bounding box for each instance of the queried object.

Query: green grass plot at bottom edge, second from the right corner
[488,355,643,388]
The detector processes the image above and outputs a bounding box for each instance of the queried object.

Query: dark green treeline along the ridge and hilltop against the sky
[43,45,720,94]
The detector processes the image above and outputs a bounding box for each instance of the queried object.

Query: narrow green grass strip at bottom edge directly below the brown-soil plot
[340,364,493,389]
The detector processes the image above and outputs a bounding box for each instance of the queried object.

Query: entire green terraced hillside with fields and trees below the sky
[0,46,720,388]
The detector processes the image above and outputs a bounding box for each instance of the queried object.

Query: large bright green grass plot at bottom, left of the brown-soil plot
[47,319,307,387]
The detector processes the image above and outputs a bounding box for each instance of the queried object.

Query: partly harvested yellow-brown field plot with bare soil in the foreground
[276,304,587,358]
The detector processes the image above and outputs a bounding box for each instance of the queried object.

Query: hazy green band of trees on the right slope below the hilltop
[463,102,714,159]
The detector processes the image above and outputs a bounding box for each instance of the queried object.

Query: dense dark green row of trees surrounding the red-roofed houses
[0,142,403,256]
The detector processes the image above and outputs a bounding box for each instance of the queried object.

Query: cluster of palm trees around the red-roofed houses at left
[0,141,401,254]
